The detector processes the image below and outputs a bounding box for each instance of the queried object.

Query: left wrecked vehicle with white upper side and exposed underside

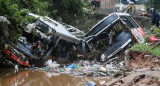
[4,13,85,66]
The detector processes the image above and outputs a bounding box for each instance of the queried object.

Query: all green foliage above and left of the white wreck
[0,0,88,44]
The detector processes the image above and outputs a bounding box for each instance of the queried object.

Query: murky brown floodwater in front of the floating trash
[0,69,106,86]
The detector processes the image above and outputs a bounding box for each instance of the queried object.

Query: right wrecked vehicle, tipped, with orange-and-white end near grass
[82,13,145,61]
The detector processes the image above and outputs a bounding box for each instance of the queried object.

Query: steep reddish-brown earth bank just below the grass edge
[130,52,160,69]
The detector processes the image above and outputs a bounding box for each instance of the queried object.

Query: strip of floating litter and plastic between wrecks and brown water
[36,60,124,77]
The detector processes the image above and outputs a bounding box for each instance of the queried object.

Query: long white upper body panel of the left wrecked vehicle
[29,13,84,44]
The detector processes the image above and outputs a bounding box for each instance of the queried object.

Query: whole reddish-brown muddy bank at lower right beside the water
[105,52,160,86]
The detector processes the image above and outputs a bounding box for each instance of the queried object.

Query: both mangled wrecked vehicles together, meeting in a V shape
[5,13,145,67]
